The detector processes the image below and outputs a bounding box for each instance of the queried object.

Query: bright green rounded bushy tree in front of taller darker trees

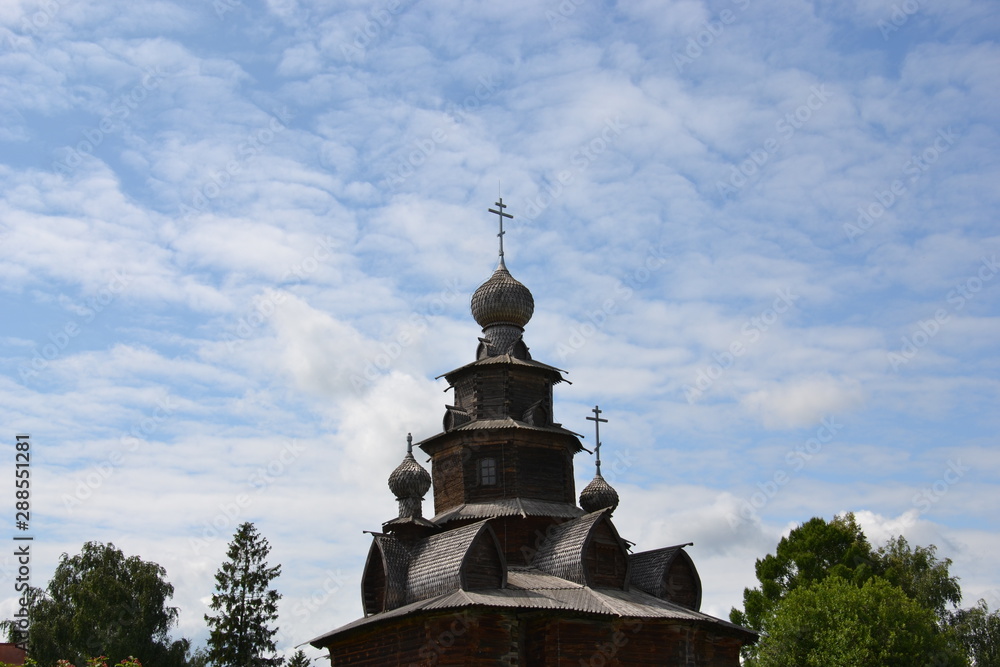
[749,576,968,667]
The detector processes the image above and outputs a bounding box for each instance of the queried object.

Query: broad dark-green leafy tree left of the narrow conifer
[28,542,189,667]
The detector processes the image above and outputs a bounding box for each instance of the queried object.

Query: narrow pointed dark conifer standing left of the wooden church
[205,522,282,667]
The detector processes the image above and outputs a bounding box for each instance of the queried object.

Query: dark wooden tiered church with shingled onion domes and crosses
[310,199,756,667]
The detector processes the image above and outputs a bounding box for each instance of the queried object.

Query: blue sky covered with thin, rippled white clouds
[0,0,1000,653]
